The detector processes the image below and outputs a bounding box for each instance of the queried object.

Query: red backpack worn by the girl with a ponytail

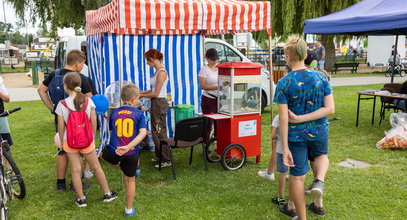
[60,97,93,149]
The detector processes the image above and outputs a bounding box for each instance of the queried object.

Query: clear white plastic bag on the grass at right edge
[376,113,407,149]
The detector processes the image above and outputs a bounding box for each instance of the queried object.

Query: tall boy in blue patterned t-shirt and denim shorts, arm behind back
[274,39,335,219]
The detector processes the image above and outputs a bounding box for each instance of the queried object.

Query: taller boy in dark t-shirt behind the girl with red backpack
[38,50,92,191]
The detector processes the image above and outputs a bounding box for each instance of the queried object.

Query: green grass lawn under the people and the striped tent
[6,84,407,219]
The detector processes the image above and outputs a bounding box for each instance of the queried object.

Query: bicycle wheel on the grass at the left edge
[3,151,26,199]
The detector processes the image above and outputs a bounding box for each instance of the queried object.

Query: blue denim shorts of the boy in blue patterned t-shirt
[288,135,328,176]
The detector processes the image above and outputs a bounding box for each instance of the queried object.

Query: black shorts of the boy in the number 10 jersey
[102,147,139,177]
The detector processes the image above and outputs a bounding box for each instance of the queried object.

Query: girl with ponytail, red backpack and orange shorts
[55,72,117,207]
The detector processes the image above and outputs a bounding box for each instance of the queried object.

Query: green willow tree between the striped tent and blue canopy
[254,0,361,70]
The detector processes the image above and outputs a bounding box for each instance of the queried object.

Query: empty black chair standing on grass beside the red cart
[158,116,208,180]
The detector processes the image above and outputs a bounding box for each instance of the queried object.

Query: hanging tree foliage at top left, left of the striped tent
[6,0,111,36]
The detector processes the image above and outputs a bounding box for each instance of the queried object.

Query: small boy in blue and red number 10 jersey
[102,84,147,217]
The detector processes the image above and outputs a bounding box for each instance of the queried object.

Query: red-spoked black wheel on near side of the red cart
[221,144,246,170]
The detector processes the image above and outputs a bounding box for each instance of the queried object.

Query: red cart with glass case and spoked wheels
[204,62,263,170]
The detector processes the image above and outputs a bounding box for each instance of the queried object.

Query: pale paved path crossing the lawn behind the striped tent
[7,75,407,102]
